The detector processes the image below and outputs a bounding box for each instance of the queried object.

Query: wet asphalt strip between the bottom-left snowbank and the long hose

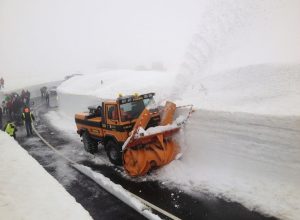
[19,124,145,220]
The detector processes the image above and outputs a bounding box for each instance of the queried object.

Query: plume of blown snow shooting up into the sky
[180,0,262,84]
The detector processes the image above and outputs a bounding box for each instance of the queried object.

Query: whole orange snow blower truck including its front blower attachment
[75,93,191,176]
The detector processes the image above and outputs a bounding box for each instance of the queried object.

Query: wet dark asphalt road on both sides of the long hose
[12,98,276,220]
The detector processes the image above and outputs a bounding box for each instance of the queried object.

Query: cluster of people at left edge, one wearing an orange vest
[0,90,35,138]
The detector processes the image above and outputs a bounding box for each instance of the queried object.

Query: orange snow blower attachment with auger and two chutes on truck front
[123,102,185,176]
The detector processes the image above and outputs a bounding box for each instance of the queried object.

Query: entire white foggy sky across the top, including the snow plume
[0,0,300,88]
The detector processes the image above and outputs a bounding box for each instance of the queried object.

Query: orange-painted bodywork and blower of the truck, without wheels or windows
[75,96,180,176]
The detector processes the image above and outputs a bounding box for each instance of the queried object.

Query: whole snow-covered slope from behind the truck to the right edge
[58,64,300,116]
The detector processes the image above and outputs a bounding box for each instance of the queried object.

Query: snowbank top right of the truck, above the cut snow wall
[177,64,300,116]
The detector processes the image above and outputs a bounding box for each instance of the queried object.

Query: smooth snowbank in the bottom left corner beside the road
[0,131,92,220]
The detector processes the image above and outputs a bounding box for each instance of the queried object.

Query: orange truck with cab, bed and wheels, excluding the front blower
[75,93,160,165]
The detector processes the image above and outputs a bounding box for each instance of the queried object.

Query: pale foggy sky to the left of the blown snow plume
[0,0,203,76]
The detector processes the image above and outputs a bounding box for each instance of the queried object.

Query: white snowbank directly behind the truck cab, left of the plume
[57,70,176,117]
